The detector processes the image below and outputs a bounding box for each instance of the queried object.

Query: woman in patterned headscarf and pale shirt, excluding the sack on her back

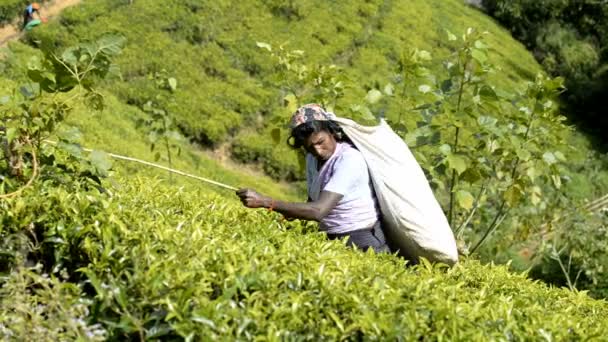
[237,104,389,252]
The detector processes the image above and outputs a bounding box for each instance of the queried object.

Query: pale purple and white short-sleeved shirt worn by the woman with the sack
[306,143,379,234]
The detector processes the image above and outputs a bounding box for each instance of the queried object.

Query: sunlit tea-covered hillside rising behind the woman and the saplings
[0,0,608,268]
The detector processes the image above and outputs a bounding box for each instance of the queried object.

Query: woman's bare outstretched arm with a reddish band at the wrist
[236,189,343,221]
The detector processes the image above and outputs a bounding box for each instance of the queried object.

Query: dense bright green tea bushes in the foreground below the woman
[0,177,608,340]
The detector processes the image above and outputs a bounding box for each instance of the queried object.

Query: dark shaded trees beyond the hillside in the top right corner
[484,0,608,149]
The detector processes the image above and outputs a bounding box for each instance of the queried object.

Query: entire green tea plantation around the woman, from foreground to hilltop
[0,0,608,341]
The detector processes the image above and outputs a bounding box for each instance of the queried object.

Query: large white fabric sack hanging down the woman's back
[332,117,458,265]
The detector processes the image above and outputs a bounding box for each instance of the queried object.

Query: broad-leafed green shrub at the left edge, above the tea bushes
[0,36,124,198]
